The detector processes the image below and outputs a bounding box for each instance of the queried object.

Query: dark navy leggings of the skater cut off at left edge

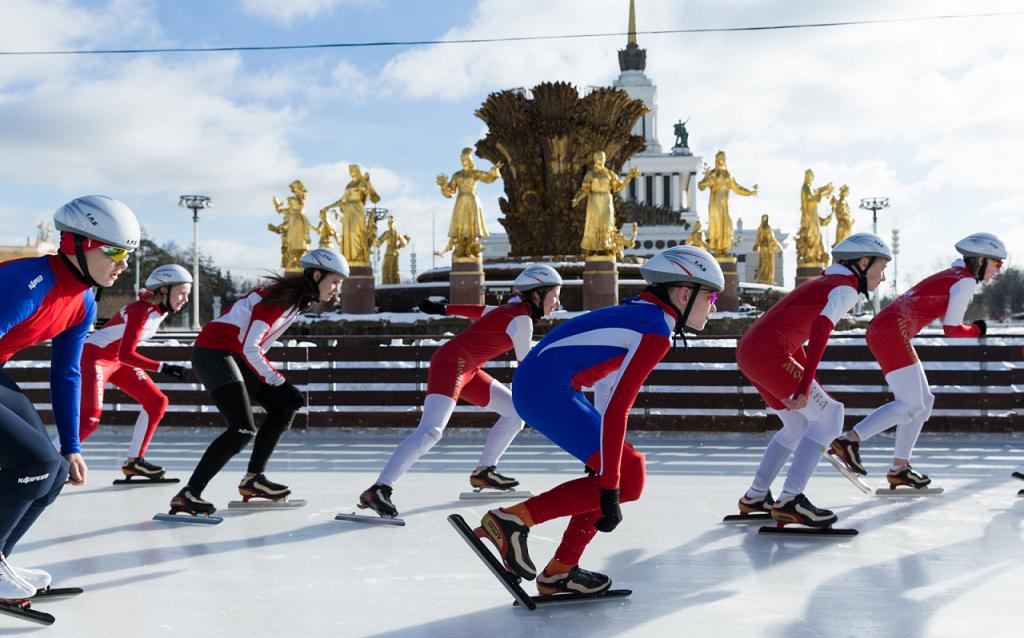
[0,369,68,556]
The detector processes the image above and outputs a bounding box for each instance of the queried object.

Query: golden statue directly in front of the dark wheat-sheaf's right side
[571,151,640,255]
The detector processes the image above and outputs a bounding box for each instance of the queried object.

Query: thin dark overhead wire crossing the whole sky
[0,10,1024,56]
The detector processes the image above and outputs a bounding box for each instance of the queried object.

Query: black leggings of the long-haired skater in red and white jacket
[188,348,302,496]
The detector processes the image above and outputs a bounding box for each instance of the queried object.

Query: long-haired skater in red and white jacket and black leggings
[171,248,348,514]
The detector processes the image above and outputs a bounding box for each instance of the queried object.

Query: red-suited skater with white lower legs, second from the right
[736,232,892,527]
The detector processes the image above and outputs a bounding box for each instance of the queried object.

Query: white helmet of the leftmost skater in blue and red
[53,195,140,250]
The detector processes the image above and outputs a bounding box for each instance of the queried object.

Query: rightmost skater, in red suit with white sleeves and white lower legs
[829,232,1007,490]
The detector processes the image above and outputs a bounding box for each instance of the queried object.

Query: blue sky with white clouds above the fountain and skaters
[0,0,1024,288]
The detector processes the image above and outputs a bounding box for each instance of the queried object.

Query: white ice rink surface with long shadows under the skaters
[12,428,1024,638]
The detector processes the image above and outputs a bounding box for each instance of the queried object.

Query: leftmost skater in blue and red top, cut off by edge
[0,196,139,599]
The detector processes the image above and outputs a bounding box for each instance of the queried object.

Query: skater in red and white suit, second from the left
[79,264,193,479]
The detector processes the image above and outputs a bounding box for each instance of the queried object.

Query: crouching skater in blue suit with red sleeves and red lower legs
[477,246,725,596]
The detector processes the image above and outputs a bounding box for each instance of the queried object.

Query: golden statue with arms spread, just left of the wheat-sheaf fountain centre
[436,148,502,259]
